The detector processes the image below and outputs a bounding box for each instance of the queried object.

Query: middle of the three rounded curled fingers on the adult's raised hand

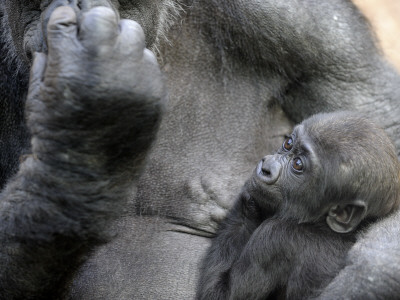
[79,6,118,52]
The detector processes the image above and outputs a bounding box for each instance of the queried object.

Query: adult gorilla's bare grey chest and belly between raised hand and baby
[70,20,291,299]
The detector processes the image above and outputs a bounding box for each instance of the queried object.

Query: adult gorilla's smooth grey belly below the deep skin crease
[70,217,209,299]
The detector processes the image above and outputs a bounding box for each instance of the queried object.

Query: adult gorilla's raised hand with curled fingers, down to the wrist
[28,6,165,176]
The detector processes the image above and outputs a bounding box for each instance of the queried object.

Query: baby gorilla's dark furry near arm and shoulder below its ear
[229,218,354,299]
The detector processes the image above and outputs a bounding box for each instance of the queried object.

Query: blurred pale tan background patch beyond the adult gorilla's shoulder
[353,0,400,71]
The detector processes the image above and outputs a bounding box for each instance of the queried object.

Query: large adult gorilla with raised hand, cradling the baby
[0,0,400,299]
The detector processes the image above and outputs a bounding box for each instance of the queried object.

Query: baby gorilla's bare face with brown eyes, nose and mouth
[250,125,326,222]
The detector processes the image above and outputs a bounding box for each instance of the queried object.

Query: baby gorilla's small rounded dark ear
[326,200,367,233]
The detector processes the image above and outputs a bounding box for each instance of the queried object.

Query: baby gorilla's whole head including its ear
[246,112,400,233]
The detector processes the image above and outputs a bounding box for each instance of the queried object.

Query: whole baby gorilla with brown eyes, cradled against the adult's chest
[197,112,400,299]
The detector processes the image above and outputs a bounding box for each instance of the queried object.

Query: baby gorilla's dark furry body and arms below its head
[198,216,354,300]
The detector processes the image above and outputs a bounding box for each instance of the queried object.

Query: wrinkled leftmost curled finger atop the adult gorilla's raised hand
[47,6,77,51]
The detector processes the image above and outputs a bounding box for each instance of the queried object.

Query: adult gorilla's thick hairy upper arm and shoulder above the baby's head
[203,0,400,144]
